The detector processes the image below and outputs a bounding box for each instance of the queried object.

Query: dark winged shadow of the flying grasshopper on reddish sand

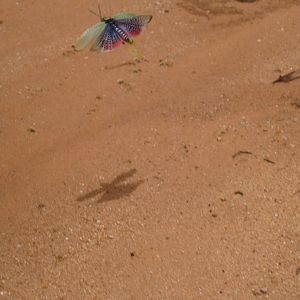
[76,169,144,203]
